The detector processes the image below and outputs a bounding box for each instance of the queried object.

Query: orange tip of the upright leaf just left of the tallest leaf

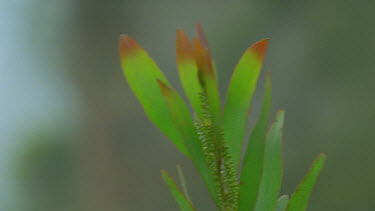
[176,29,194,62]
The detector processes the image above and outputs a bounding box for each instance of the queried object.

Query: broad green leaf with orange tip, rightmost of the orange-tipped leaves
[223,39,268,169]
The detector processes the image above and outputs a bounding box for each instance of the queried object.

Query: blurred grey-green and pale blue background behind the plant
[0,0,375,211]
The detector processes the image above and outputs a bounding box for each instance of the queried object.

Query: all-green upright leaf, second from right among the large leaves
[255,110,284,211]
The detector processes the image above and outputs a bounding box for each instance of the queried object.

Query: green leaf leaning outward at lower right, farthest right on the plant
[287,154,326,211]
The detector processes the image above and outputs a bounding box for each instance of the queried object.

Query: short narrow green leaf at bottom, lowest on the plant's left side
[161,170,195,211]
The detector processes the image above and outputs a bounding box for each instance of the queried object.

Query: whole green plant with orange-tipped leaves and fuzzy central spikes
[119,23,325,211]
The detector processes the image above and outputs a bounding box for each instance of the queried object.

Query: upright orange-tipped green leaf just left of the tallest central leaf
[176,29,202,117]
